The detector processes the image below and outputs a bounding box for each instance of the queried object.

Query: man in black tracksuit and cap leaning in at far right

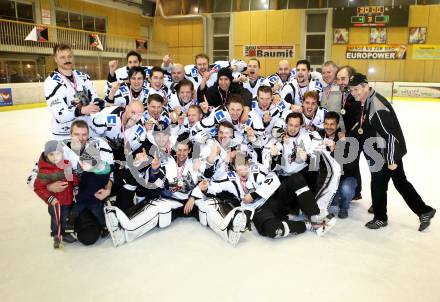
[349,73,435,231]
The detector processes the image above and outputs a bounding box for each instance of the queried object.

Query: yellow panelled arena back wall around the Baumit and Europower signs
[153,5,440,82]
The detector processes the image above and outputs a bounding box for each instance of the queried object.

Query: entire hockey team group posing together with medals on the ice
[27,44,436,249]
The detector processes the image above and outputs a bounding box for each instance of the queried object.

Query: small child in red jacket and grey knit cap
[34,140,79,248]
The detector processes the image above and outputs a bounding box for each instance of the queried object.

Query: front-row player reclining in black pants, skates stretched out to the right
[232,152,335,238]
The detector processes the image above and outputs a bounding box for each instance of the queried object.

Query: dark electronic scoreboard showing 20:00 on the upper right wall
[333,6,409,28]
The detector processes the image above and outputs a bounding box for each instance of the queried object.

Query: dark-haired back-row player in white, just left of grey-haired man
[290,60,323,106]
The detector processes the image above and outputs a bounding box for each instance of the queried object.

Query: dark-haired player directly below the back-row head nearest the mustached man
[105,66,149,107]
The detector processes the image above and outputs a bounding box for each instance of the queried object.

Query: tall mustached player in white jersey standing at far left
[44,44,104,140]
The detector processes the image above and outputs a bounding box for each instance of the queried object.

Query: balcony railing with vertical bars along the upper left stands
[0,19,168,60]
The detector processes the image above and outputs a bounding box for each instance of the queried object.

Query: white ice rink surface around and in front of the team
[0,101,440,302]
